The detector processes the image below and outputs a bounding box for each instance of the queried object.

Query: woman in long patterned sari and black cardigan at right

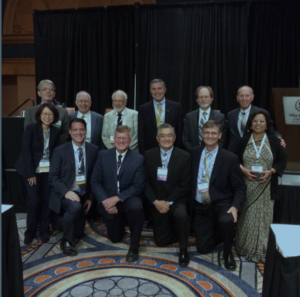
[236,111,287,263]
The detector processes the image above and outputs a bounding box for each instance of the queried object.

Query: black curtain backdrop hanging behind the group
[34,0,300,113]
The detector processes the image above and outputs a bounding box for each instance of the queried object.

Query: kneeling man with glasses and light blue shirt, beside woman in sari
[191,120,246,270]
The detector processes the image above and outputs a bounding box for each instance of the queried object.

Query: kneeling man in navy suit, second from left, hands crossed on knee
[92,125,145,262]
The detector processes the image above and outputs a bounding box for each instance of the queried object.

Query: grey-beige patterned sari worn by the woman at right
[236,137,274,263]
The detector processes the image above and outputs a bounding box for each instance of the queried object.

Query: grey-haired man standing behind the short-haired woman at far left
[24,79,69,143]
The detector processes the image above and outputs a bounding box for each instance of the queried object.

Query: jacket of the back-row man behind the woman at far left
[24,105,69,144]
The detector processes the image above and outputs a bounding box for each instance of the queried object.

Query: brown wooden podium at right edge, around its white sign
[272,88,300,173]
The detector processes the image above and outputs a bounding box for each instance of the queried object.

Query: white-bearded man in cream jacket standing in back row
[102,90,138,152]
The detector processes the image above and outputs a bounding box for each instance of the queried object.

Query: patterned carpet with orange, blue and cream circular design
[17,214,264,297]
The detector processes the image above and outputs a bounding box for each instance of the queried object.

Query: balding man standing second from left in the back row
[69,91,105,150]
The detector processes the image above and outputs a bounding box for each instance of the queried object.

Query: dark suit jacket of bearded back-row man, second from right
[182,108,227,151]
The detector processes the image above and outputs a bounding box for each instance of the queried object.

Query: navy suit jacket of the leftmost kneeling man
[49,141,99,214]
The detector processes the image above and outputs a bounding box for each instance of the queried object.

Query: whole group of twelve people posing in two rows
[16,79,287,270]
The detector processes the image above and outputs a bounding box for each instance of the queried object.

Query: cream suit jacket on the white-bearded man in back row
[102,107,139,152]
